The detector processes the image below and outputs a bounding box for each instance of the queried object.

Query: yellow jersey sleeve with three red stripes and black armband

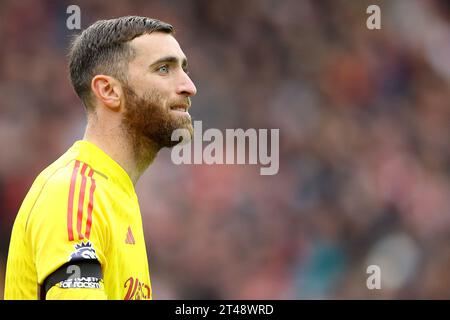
[27,161,108,299]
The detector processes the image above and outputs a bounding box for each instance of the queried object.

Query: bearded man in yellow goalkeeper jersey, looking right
[5,16,196,299]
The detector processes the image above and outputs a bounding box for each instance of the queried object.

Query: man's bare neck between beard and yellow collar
[83,119,160,185]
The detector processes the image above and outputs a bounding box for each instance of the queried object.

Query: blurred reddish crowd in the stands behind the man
[0,0,450,299]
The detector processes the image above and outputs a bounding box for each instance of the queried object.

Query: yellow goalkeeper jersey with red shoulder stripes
[5,141,152,300]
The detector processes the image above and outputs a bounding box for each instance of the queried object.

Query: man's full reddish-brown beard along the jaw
[122,85,194,154]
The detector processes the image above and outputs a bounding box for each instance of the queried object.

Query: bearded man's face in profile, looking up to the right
[123,32,197,148]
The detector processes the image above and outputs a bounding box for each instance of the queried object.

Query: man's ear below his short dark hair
[91,74,122,111]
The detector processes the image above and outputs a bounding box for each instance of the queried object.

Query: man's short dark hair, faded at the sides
[69,16,174,110]
